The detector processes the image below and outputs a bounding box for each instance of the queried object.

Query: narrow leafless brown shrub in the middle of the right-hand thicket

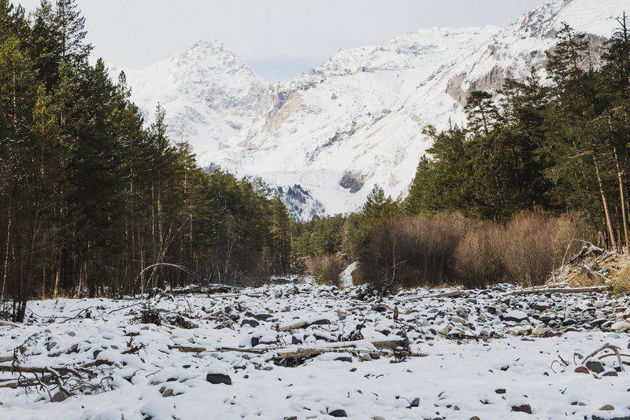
[455,222,507,288]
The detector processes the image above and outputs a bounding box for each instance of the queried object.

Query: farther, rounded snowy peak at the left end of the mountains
[125,41,270,165]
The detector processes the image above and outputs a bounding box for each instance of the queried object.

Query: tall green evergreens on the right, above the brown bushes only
[404,16,630,250]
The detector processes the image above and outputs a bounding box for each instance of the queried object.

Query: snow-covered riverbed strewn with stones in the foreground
[0,285,630,420]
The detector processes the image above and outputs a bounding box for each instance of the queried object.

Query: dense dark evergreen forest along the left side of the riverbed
[0,0,291,320]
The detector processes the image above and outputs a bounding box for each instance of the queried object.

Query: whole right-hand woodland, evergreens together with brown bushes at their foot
[296,16,630,290]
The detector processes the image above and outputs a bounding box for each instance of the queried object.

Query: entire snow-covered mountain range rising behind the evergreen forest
[121,0,630,217]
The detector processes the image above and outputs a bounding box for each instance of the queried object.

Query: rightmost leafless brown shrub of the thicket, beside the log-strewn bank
[499,212,590,286]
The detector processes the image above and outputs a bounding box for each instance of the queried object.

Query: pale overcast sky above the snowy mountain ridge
[16,0,543,81]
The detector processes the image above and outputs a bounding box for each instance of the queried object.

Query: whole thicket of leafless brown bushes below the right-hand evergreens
[358,212,592,290]
